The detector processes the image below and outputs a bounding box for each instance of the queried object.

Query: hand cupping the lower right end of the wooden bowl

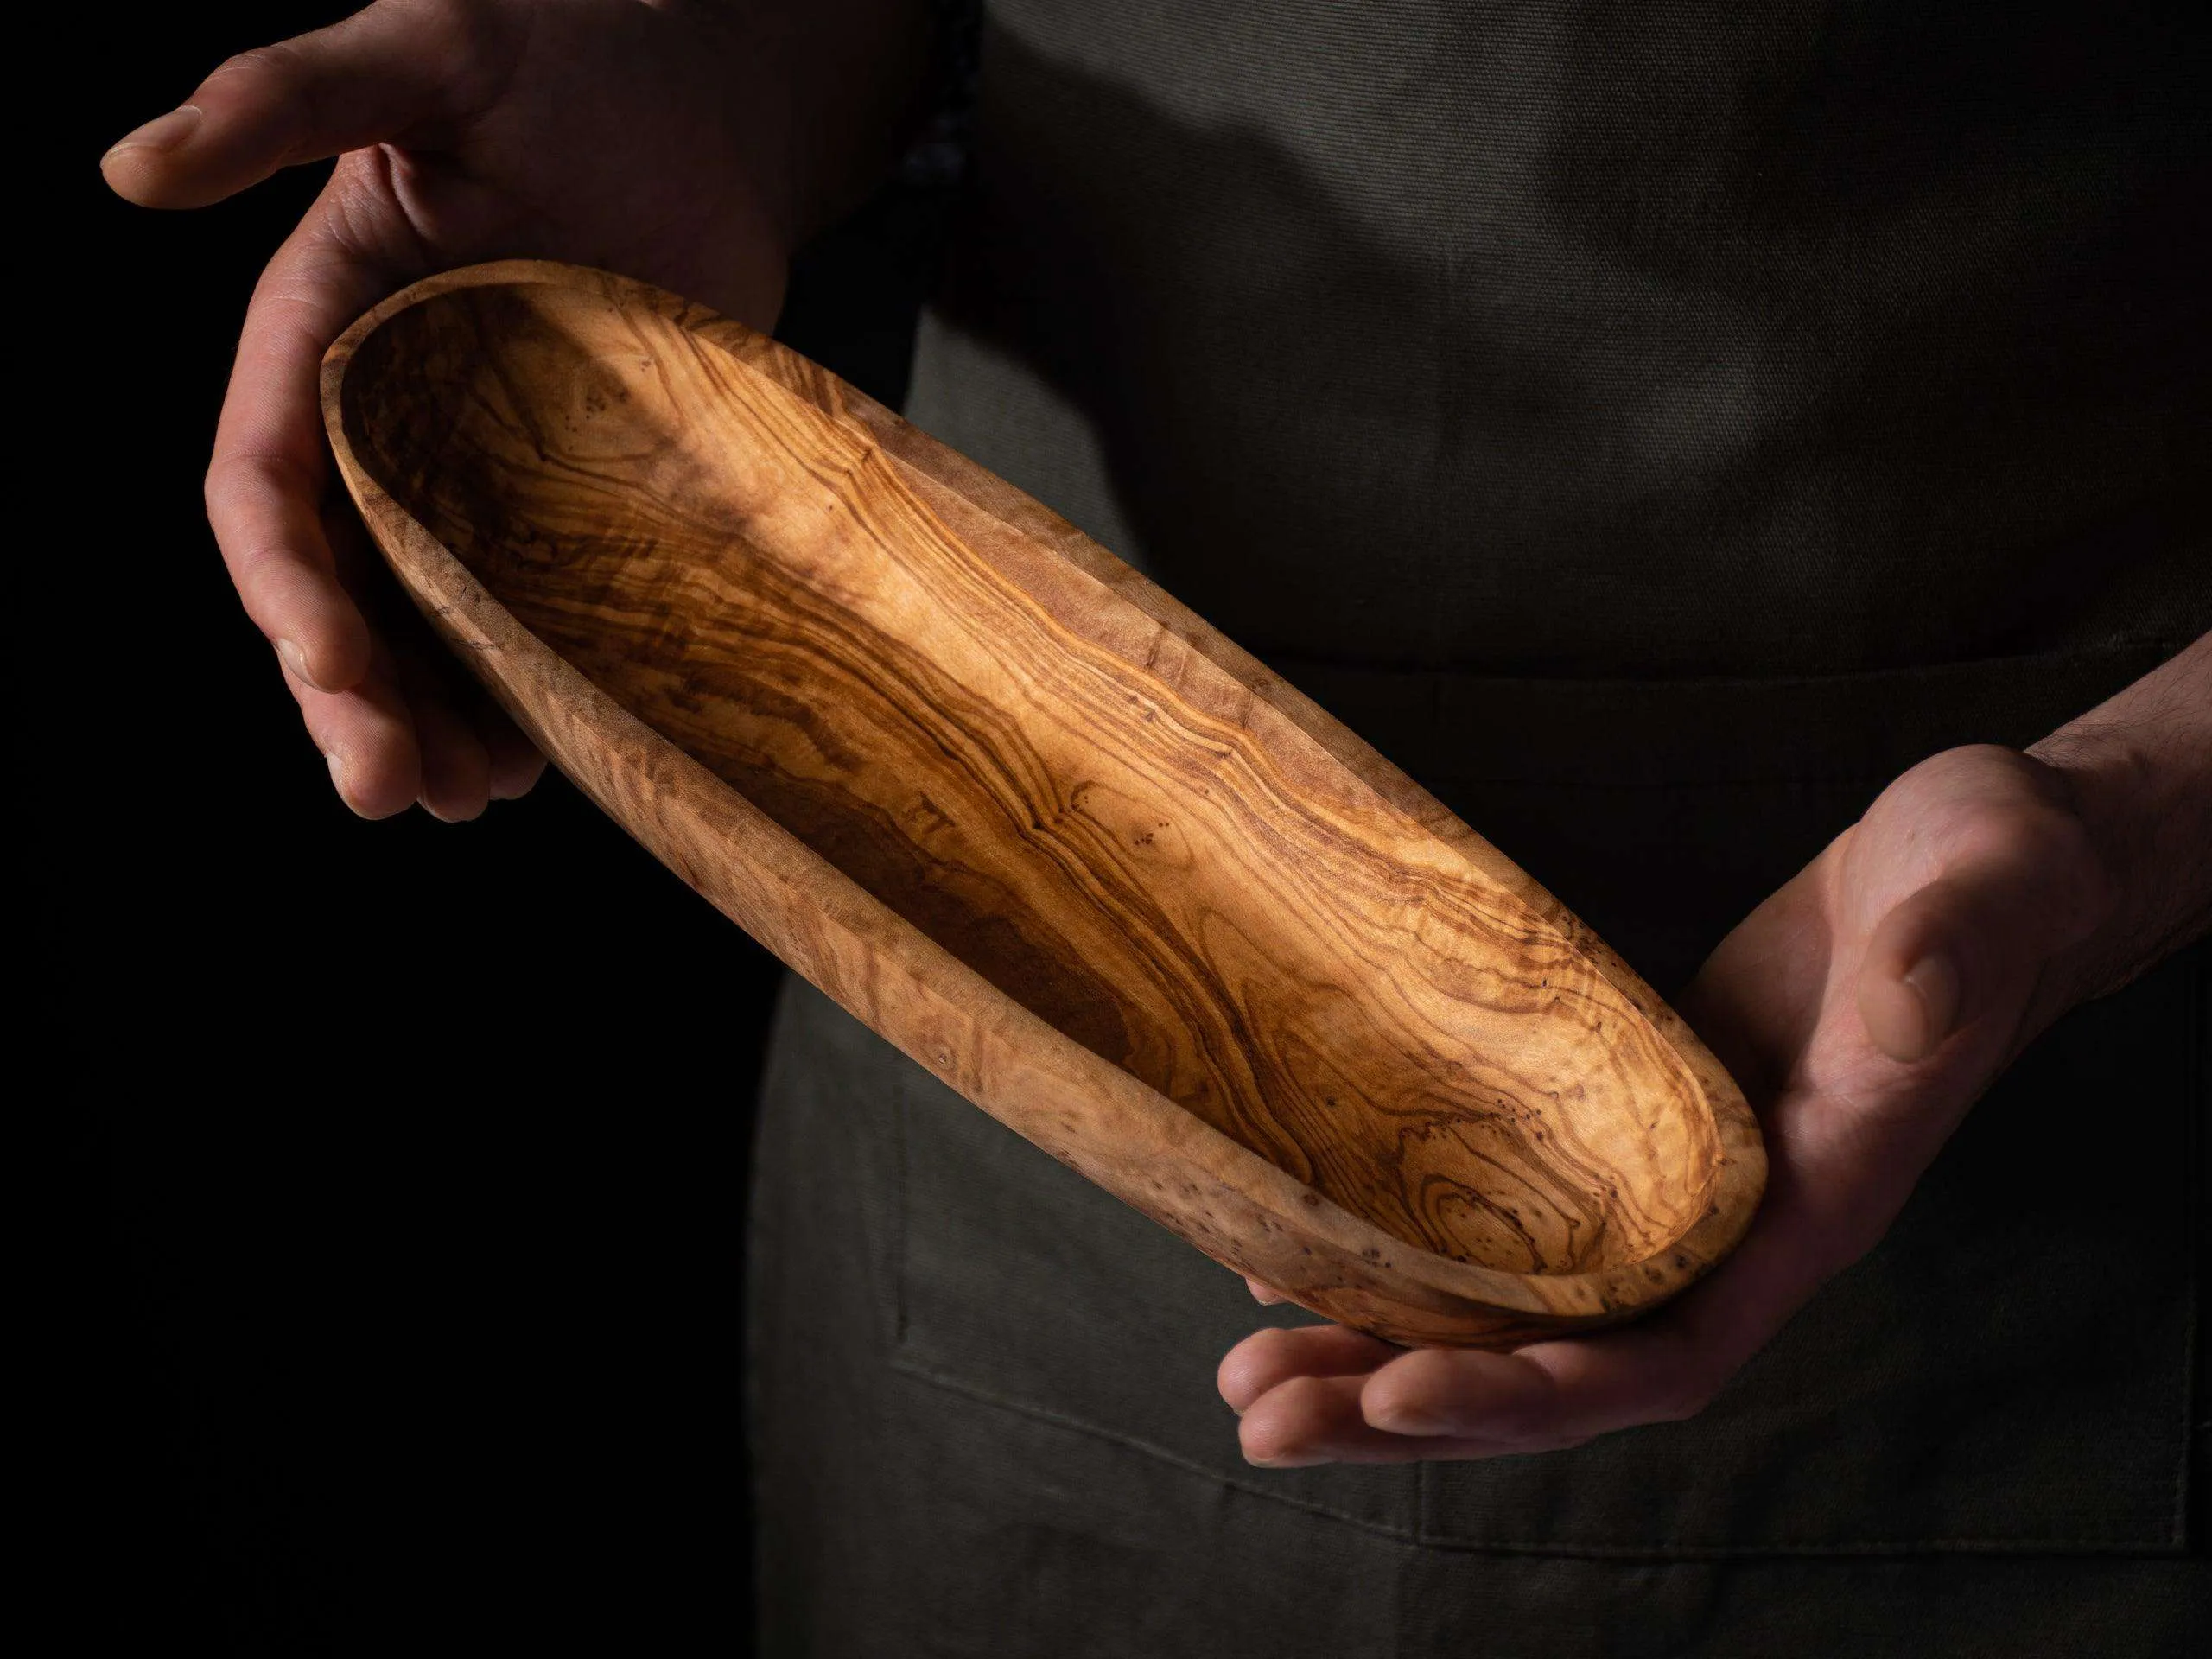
[1219,747,2117,1466]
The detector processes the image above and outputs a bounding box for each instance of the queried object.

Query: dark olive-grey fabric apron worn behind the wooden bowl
[750,0,2212,1659]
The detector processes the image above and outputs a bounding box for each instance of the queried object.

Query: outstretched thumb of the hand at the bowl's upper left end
[99,0,522,208]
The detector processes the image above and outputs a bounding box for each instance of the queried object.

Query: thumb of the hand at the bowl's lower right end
[1858,803,2113,1062]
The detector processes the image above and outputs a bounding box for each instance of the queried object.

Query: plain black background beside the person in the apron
[52,4,936,1655]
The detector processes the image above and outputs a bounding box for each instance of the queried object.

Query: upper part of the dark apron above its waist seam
[912,0,2212,679]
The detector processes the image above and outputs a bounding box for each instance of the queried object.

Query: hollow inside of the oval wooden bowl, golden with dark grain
[343,283,1719,1274]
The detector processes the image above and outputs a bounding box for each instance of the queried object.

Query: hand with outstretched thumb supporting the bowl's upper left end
[102,0,898,818]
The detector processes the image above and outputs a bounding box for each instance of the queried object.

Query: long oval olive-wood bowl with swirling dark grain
[323,264,1765,1344]
